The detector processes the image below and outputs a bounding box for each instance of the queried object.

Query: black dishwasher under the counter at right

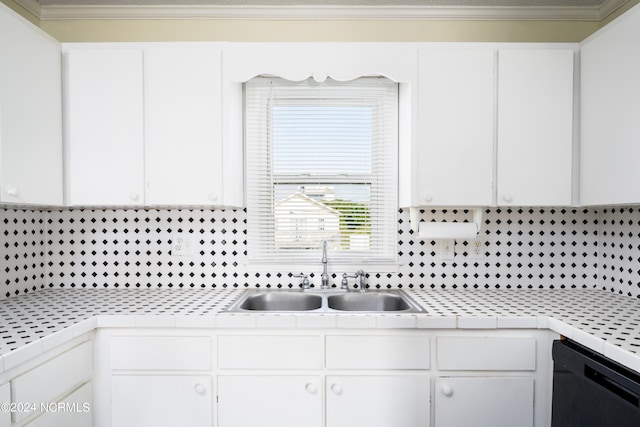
[551,340,640,427]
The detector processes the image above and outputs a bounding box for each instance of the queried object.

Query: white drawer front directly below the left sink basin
[218,335,324,369]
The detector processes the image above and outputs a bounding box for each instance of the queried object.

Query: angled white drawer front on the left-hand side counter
[11,342,93,422]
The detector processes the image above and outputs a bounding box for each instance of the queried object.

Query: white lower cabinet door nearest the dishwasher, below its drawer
[434,377,533,427]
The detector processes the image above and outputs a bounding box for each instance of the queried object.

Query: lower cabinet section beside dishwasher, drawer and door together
[433,333,550,427]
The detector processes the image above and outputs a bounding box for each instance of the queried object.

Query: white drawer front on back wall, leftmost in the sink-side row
[110,336,211,371]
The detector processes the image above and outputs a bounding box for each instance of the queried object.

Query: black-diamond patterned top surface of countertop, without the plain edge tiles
[0,289,640,362]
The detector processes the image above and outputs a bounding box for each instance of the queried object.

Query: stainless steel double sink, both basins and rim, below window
[227,289,423,313]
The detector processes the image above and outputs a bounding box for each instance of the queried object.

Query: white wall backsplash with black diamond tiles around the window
[0,207,640,298]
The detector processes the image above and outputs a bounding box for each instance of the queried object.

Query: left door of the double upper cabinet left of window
[66,48,144,206]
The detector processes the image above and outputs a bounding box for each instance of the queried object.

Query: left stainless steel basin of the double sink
[232,291,322,311]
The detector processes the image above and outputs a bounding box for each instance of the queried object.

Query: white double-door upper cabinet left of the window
[65,43,243,206]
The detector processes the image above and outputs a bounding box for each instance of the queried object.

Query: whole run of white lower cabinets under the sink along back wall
[96,329,555,427]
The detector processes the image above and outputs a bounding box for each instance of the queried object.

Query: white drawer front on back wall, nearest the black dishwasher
[436,337,536,371]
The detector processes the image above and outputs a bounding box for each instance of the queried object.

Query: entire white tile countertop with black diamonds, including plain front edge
[0,289,640,372]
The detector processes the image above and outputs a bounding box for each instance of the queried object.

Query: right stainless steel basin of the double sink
[327,292,411,311]
